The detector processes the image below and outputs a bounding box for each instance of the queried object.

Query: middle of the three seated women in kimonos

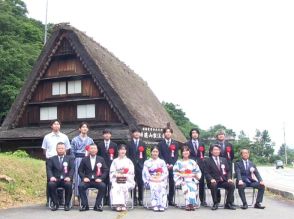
[142,146,168,211]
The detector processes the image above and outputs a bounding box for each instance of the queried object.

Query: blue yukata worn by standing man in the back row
[70,135,94,196]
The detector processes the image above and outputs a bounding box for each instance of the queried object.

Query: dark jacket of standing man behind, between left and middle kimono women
[127,139,147,171]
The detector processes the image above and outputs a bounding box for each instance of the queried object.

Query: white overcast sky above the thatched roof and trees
[25,0,294,150]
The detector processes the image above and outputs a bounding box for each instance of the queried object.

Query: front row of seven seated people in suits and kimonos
[47,142,264,211]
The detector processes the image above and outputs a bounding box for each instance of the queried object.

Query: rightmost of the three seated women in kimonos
[173,145,201,211]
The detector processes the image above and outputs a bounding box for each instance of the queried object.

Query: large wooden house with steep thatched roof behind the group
[0,24,185,151]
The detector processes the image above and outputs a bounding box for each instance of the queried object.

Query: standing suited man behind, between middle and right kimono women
[158,127,179,206]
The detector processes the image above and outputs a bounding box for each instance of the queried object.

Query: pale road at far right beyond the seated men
[258,167,294,195]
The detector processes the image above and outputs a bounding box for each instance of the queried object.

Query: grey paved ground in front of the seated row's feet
[0,194,294,219]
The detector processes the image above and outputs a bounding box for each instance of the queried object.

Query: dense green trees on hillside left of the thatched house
[0,0,44,117]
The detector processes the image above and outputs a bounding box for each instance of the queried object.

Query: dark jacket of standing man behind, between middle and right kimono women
[158,139,179,165]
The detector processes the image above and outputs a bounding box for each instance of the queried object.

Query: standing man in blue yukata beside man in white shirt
[71,122,94,196]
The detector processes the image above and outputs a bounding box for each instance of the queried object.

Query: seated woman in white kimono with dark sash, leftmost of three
[109,144,135,211]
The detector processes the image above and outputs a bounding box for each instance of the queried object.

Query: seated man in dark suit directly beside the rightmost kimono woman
[204,144,236,210]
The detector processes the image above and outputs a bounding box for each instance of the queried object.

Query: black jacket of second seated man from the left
[79,156,109,181]
